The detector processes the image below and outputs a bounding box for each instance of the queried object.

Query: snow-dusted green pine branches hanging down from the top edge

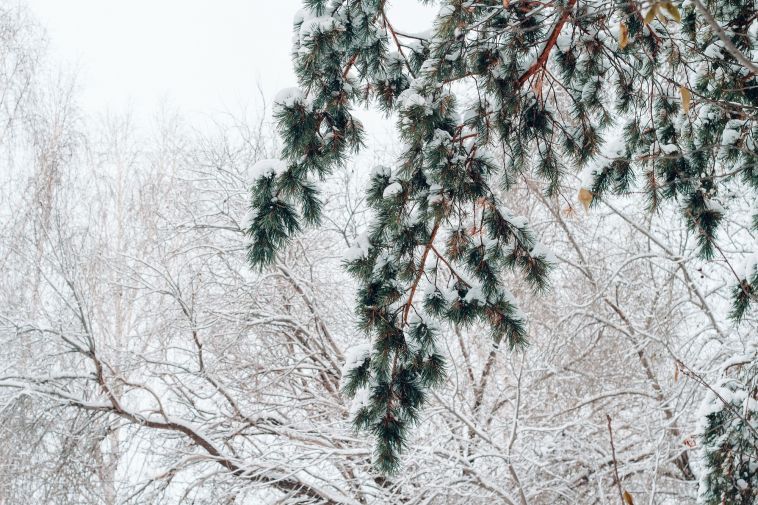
[248,0,758,471]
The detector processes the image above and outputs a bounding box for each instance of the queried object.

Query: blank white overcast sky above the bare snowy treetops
[28,0,430,124]
